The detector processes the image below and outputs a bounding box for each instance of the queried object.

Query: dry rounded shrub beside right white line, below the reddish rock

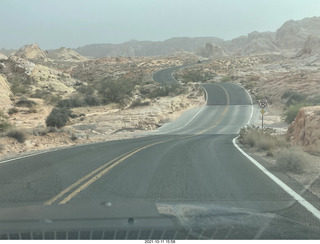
[276,147,310,174]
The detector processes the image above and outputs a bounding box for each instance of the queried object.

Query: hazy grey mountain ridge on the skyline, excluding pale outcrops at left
[73,17,320,57]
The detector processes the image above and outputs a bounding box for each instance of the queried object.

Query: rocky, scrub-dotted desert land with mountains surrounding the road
[0,17,320,196]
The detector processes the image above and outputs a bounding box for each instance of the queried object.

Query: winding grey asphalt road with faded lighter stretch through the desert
[0,66,316,238]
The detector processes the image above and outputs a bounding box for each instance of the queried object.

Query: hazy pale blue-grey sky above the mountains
[0,0,320,49]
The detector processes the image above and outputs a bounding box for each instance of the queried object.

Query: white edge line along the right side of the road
[232,85,320,220]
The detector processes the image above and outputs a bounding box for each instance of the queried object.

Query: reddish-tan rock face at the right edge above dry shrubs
[286,106,320,154]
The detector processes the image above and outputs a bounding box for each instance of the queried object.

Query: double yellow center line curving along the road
[43,85,230,205]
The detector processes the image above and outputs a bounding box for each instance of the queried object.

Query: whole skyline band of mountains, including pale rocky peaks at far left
[0,17,320,58]
